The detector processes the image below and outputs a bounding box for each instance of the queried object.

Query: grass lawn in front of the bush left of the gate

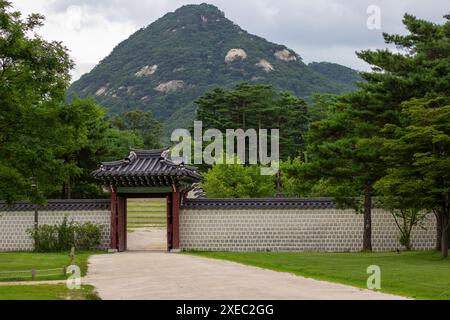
[0,251,103,282]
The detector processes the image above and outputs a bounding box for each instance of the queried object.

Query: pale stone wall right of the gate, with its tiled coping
[180,199,436,252]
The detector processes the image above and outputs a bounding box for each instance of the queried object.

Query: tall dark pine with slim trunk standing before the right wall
[309,14,450,250]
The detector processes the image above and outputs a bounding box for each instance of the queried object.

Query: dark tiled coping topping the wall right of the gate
[182,198,336,209]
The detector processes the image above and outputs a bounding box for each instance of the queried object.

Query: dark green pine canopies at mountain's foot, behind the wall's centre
[196,83,308,159]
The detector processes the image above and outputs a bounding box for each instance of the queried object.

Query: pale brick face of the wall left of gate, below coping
[0,209,111,251]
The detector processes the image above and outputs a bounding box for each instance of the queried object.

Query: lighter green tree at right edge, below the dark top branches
[376,97,450,257]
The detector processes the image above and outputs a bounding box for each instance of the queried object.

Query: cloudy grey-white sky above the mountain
[12,0,450,80]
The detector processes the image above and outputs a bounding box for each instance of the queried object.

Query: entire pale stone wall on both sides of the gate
[0,199,436,252]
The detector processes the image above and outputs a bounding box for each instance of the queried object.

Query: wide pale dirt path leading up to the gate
[83,252,410,300]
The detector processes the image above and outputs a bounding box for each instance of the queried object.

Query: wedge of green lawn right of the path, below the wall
[188,251,450,299]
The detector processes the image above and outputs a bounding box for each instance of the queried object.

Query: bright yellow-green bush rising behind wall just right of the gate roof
[202,158,276,198]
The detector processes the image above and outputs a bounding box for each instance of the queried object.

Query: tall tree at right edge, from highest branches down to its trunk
[360,15,450,257]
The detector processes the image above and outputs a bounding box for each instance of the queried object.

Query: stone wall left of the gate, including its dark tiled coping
[0,200,111,251]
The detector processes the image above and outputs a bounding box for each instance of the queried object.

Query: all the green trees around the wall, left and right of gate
[0,0,450,257]
